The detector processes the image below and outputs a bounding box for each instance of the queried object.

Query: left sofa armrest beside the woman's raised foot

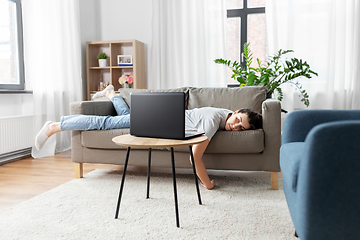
[70,101,116,116]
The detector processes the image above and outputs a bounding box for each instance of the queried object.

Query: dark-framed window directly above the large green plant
[226,0,267,83]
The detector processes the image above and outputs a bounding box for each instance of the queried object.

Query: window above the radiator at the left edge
[0,0,24,91]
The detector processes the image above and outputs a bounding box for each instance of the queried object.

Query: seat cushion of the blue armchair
[280,142,305,192]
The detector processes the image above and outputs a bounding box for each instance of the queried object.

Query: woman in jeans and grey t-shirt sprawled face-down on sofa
[35,85,262,189]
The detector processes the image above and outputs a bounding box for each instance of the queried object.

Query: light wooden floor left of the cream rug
[0,151,122,210]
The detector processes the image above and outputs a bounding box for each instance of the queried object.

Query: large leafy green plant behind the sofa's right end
[215,43,318,107]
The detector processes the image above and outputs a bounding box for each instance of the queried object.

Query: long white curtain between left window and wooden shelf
[22,0,82,158]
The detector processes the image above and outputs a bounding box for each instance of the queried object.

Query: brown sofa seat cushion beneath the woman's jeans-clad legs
[81,128,166,150]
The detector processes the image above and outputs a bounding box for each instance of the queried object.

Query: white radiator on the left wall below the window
[0,115,34,155]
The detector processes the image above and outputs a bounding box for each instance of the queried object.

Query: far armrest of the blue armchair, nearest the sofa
[282,110,360,144]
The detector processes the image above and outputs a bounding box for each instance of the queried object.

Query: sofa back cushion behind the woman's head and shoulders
[188,86,266,113]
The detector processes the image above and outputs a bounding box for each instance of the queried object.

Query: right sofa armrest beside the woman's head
[262,99,281,172]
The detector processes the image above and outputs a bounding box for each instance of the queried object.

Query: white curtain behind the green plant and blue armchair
[266,0,360,111]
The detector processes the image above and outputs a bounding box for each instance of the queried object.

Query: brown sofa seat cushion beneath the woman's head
[174,129,264,153]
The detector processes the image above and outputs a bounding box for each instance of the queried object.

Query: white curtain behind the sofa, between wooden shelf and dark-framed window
[148,0,226,89]
